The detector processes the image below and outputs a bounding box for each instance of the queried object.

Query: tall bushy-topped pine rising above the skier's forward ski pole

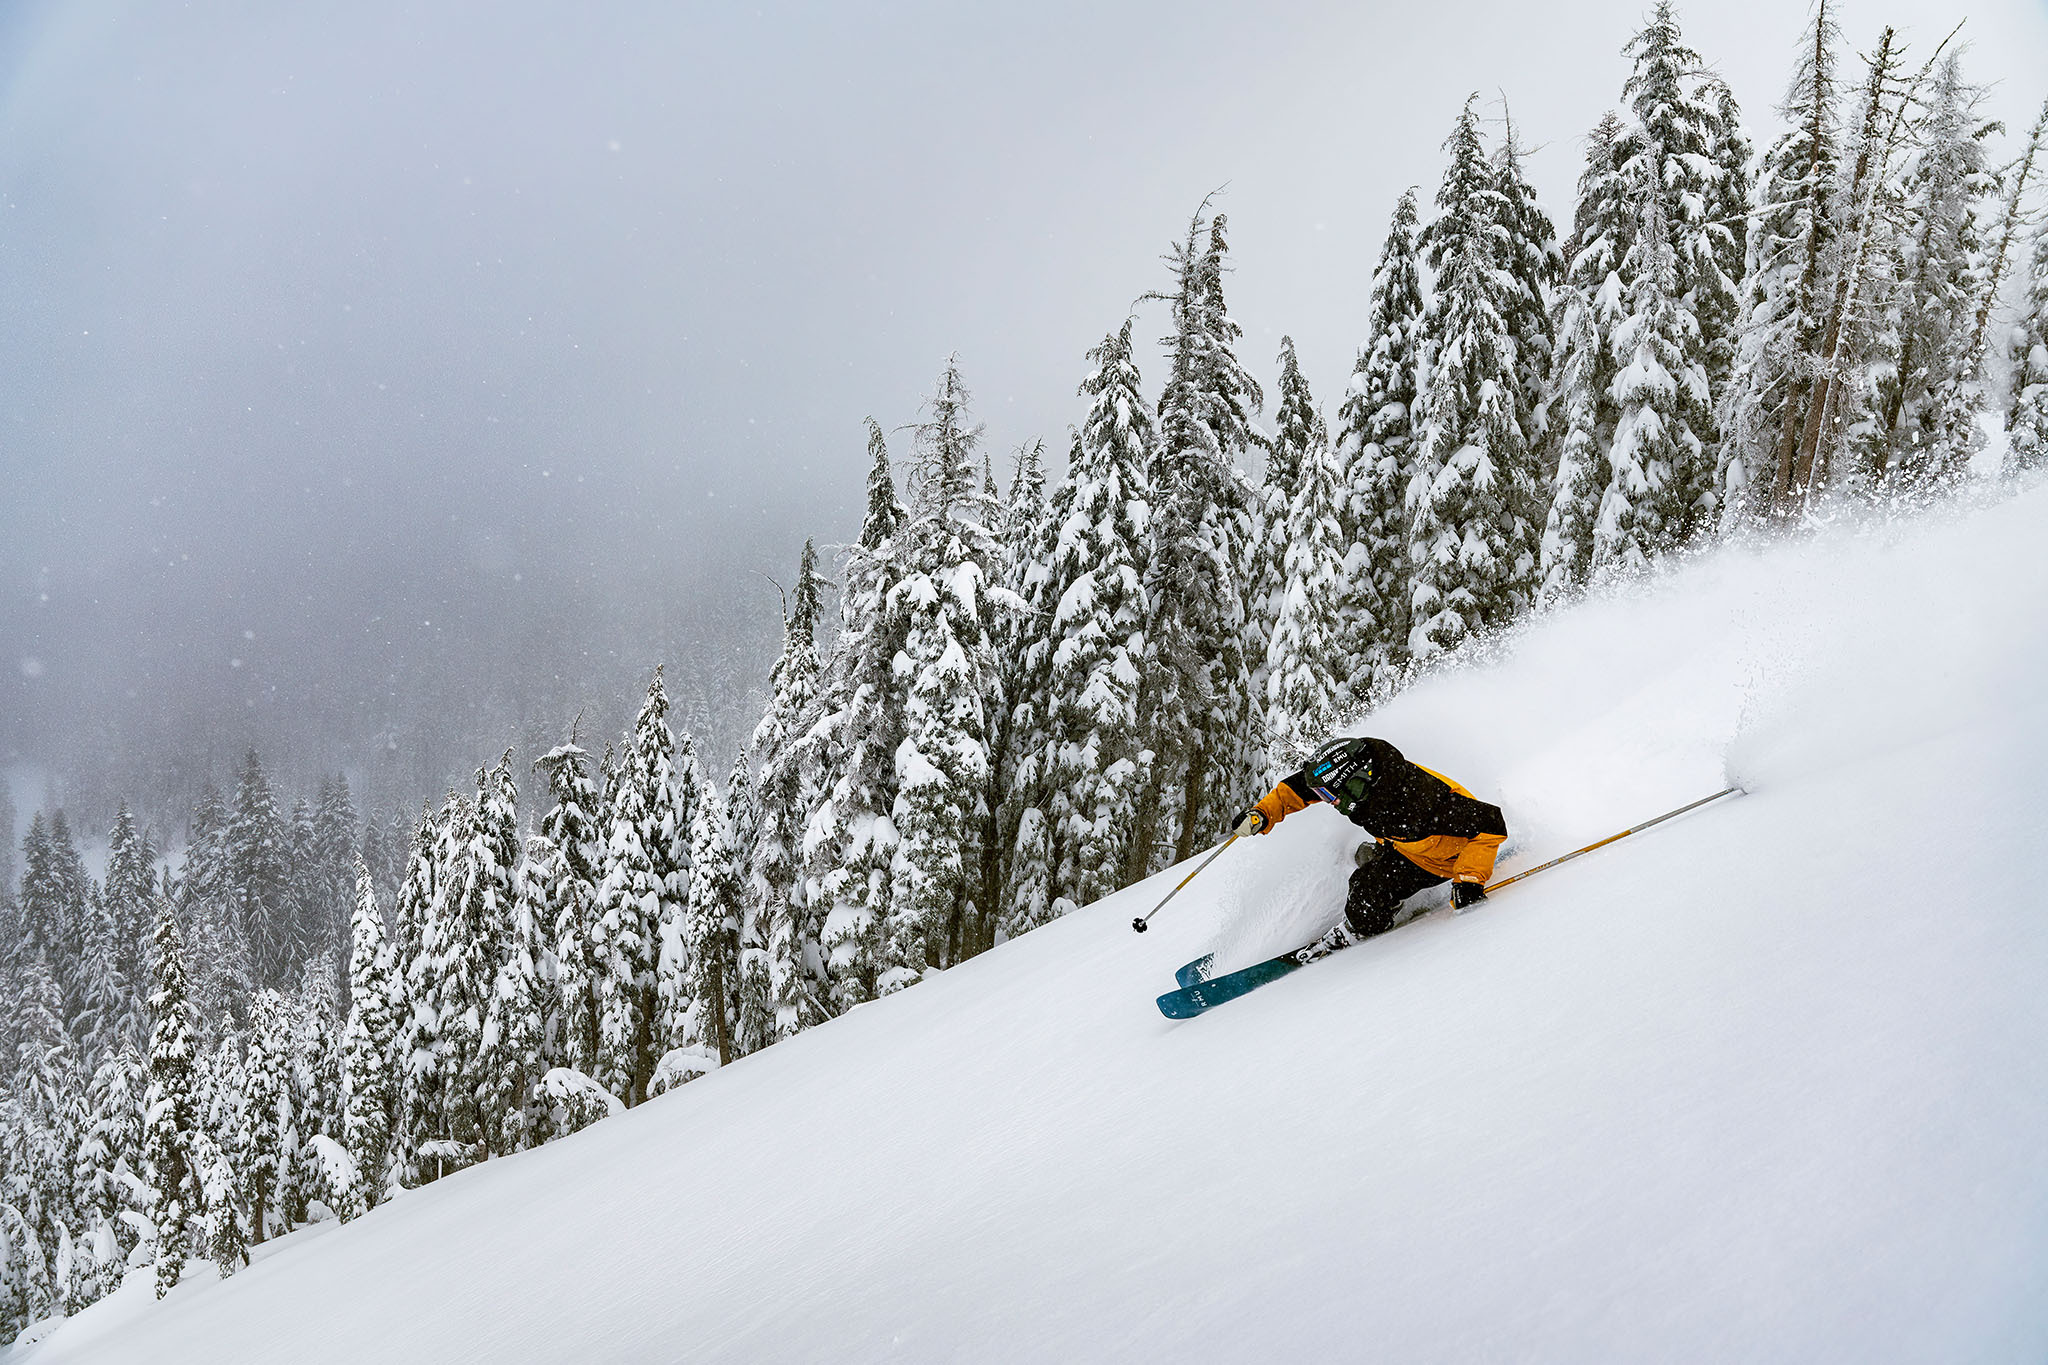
[1128,201,1264,880]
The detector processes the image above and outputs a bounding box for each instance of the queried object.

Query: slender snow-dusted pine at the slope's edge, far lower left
[143,905,205,1297]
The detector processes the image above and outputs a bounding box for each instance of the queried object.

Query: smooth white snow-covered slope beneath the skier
[16,489,2048,1365]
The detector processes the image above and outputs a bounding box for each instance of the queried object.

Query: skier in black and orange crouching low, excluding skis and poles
[1233,739,1507,964]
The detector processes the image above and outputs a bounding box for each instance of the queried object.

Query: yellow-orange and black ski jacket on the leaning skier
[1257,739,1507,886]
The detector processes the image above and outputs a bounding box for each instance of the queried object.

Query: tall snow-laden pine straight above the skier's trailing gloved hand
[1407,96,1536,659]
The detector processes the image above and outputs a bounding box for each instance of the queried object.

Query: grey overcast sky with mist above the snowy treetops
[0,0,2048,822]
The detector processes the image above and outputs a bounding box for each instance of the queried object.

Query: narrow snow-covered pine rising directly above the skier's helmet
[1266,338,1346,769]
